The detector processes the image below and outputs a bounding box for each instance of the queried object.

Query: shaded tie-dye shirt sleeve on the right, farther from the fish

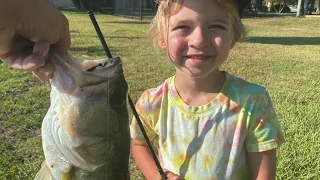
[245,90,284,152]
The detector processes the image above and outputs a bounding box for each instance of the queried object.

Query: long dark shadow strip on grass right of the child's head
[245,37,320,45]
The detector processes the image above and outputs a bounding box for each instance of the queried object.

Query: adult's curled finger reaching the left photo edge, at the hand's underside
[3,42,50,71]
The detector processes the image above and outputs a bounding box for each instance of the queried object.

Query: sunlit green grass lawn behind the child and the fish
[0,12,320,180]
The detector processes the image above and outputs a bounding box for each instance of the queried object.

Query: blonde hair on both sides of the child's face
[149,0,246,48]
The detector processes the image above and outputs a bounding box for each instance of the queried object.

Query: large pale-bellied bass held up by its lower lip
[35,53,130,180]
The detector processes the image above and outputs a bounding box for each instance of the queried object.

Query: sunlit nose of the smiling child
[189,28,209,48]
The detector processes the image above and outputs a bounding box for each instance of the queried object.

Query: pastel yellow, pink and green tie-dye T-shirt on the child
[130,73,284,180]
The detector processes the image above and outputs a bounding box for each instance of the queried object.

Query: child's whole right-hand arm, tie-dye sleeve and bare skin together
[245,89,284,180]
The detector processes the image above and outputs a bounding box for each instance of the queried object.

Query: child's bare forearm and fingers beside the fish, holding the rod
[132,140,179,180]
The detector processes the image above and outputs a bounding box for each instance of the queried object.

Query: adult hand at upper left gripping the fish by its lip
[0,0,70,80]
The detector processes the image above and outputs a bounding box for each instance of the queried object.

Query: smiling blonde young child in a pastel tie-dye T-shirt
[130,0,284,180]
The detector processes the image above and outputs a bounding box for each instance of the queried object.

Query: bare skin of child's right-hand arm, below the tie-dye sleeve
[248,149,277,180]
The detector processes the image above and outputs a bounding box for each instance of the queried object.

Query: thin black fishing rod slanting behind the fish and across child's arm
[85,0,167,179]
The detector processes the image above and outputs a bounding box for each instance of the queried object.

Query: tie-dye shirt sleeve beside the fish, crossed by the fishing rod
[130,91,157,141]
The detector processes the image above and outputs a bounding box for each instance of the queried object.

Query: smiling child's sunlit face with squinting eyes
[166,0,233,78]
